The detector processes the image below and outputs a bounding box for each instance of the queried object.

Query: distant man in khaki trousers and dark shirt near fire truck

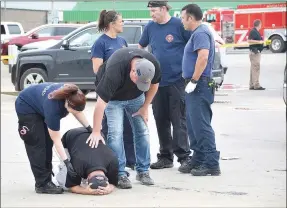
[248,19,265,90]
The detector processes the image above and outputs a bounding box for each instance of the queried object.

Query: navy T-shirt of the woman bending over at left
[15,83,68,131]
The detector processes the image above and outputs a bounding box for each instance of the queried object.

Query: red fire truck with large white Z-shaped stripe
[204,3,286,53]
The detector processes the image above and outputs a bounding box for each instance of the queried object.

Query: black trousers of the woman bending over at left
[18,114,53,187]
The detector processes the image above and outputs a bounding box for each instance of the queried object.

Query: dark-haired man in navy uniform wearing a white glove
[181,4,221,176]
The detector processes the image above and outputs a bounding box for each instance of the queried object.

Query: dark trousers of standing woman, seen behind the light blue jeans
[102,112,136,166]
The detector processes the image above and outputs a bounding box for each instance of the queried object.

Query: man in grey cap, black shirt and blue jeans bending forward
[87,48,161,189]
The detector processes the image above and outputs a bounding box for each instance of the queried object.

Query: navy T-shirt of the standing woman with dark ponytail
[92,34,128,62]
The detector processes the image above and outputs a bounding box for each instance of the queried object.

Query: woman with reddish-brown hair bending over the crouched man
[15,83,92,194]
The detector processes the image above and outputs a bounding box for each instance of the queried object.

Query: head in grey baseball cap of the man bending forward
[130,58,155,92]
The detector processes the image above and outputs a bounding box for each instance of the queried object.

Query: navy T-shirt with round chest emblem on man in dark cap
[139,17,191,86]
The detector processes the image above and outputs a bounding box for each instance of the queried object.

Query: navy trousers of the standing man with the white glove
[185,77,220,168]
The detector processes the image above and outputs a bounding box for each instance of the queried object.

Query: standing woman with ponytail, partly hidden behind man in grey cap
[92,10,136,169]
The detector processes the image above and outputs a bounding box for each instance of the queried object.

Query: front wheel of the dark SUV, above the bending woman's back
[20,68,48,90]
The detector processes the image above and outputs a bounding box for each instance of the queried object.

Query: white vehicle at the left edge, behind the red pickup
[1,22,25,43]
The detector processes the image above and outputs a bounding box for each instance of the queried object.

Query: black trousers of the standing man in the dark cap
[152,79,191,162]
